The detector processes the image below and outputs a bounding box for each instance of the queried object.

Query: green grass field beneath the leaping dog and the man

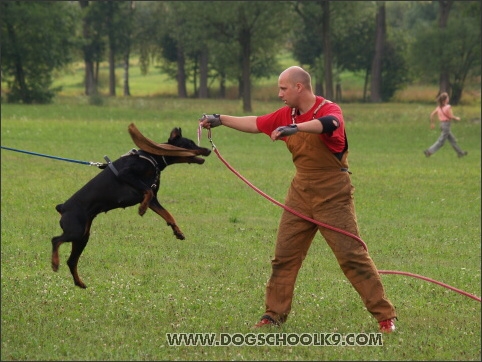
[1,96,481,361]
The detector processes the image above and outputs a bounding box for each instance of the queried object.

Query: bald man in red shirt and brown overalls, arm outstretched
[200,66,396,333]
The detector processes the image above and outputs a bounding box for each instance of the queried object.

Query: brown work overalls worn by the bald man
[265,132,396,323]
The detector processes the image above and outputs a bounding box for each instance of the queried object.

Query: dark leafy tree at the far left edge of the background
[0,1,76,104]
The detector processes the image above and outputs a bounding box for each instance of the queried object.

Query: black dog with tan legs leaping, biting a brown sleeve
[52,128,211,288]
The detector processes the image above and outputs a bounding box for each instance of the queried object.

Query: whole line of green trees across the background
[0,0,481,108]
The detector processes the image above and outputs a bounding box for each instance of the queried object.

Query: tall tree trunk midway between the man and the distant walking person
[370,1,385,102]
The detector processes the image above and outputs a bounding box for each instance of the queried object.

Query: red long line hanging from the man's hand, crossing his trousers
[208,141,481,302]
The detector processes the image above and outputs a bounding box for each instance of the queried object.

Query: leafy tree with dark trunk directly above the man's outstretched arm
[204,2,289,103]
